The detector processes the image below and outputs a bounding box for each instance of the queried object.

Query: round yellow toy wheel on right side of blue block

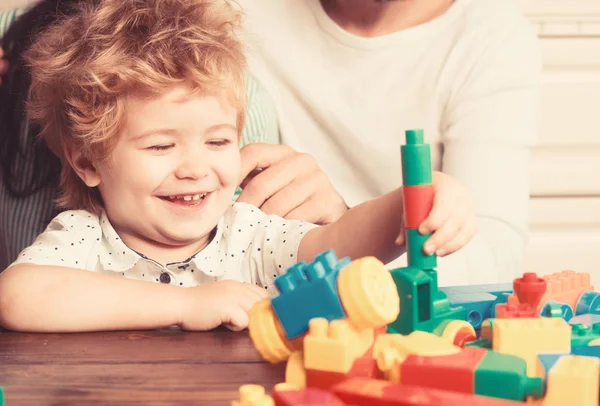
[338,257,400,329]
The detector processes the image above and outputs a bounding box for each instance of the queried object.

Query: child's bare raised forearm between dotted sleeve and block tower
[298,189,405,263]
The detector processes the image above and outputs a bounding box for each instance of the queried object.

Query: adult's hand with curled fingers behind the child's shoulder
[237,143,348,225]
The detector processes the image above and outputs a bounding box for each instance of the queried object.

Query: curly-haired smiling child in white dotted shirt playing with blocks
[0,0,475,332]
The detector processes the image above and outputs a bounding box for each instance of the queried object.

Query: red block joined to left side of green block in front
[400,347,487,393]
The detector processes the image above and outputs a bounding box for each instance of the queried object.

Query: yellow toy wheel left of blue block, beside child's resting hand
[248,299,301,363]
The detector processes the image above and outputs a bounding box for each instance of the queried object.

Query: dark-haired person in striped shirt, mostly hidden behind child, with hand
[0,0,346,270]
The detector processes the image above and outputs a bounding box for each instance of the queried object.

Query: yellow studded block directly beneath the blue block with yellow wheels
[304,317,375,373]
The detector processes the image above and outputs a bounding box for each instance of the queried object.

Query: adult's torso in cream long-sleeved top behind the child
[240,0,541,284]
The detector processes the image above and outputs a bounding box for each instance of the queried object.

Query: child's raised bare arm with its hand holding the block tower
[298,172,476,263]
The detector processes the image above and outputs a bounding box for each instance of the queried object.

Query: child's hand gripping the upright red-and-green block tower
[410,171,477,257]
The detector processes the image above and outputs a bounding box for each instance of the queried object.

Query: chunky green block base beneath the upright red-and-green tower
[388,266,466,334]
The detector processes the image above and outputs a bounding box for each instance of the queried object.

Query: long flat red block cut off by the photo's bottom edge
[332,378,524,406]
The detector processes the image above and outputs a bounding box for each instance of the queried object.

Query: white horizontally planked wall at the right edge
[521,0,600,287]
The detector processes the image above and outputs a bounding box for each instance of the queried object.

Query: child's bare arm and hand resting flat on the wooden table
[0,264,265,332]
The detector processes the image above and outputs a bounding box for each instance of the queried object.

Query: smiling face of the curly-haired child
[85,87,240,260]
